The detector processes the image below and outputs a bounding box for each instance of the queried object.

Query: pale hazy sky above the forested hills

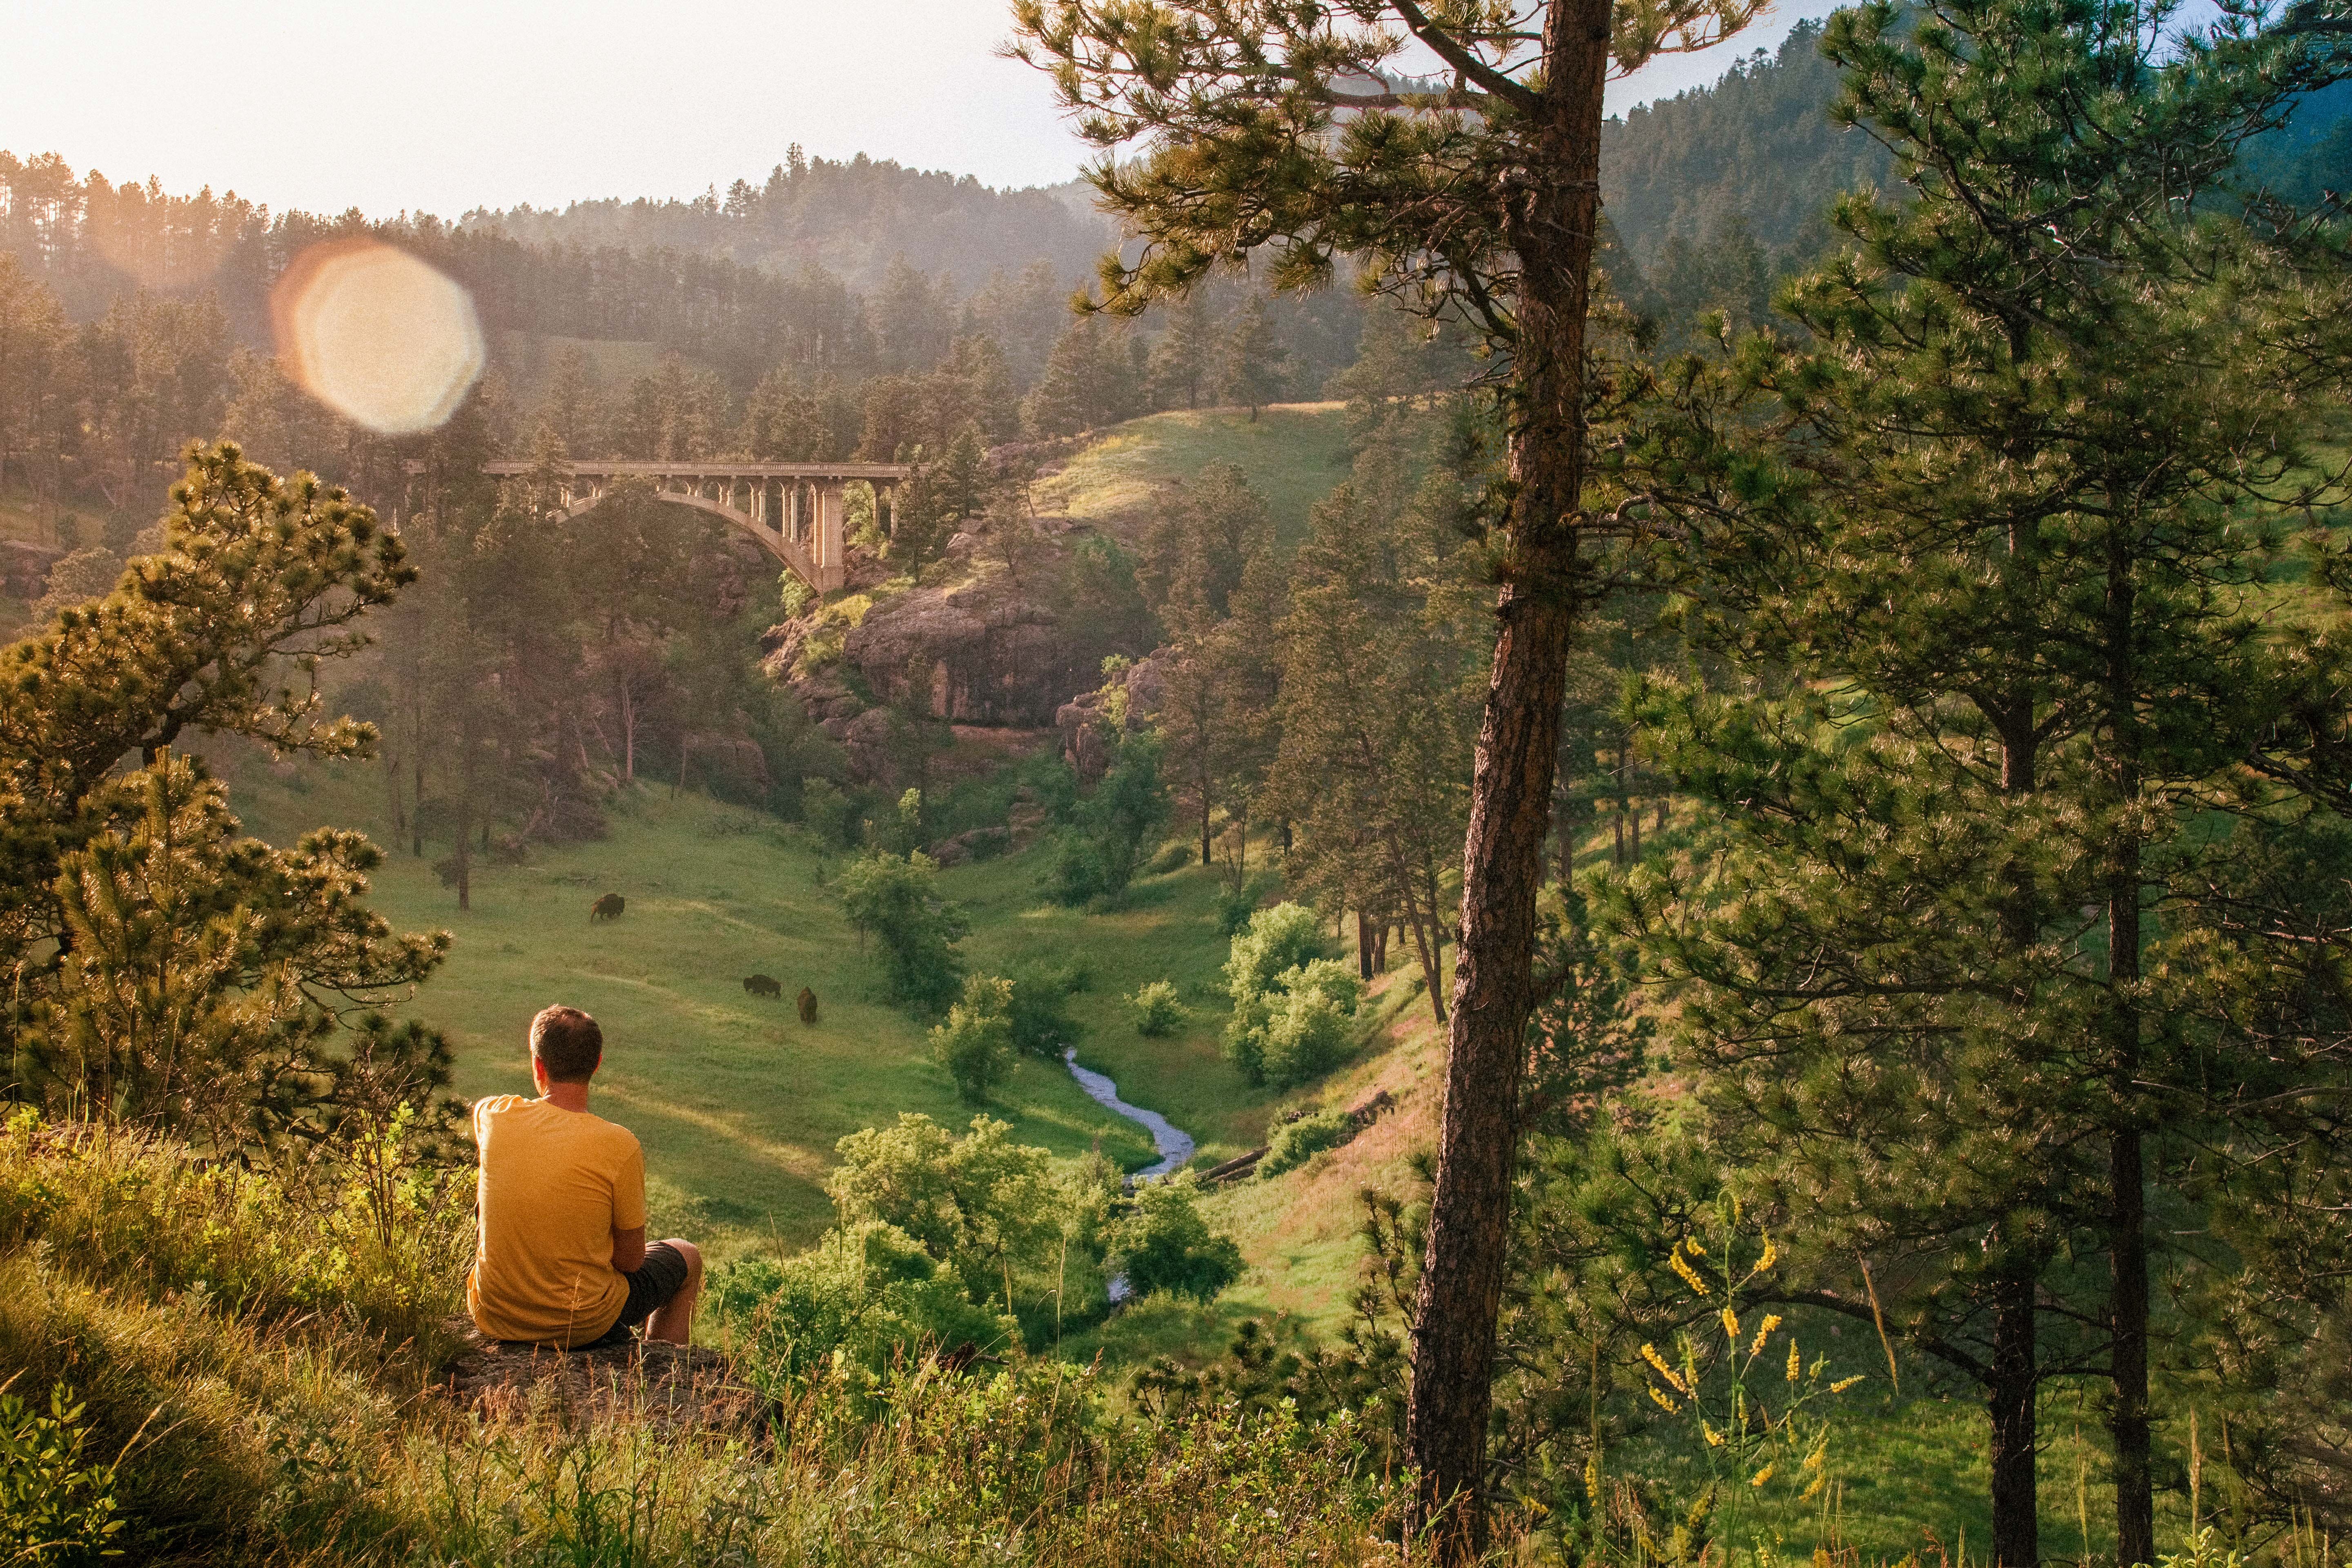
[0,0,1830,216]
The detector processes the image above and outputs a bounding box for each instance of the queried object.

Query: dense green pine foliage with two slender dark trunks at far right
[1632,0,2340,1563]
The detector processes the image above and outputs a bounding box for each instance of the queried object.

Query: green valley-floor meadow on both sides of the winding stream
[222,766,1307,1246]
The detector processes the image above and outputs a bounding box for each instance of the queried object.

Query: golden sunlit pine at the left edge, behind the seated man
[0,444,447,1154]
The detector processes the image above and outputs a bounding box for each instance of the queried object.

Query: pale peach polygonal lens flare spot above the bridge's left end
[270,240,485,435]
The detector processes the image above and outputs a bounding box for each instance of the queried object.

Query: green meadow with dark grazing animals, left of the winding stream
[238,776,1185,1251]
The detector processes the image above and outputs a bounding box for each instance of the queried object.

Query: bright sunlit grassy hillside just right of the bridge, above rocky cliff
[1037,402,1352,541]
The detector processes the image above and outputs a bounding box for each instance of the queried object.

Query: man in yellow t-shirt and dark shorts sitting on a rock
[466,1006,703,1350]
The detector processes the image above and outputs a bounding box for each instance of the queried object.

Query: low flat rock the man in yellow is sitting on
[437,1319,767,1434]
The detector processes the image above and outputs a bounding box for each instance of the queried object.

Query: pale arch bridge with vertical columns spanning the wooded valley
[482,459,915,592]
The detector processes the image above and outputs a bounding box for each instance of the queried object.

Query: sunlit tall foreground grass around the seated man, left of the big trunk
[0,1117,1397,1568]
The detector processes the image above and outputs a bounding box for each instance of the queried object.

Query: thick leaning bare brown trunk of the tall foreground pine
[1406,0,1611,1566]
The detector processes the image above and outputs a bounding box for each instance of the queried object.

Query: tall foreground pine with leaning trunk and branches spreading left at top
[1014,0,1755,1563]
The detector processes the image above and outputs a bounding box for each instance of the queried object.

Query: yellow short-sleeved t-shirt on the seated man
[466,1096,644,1345]
